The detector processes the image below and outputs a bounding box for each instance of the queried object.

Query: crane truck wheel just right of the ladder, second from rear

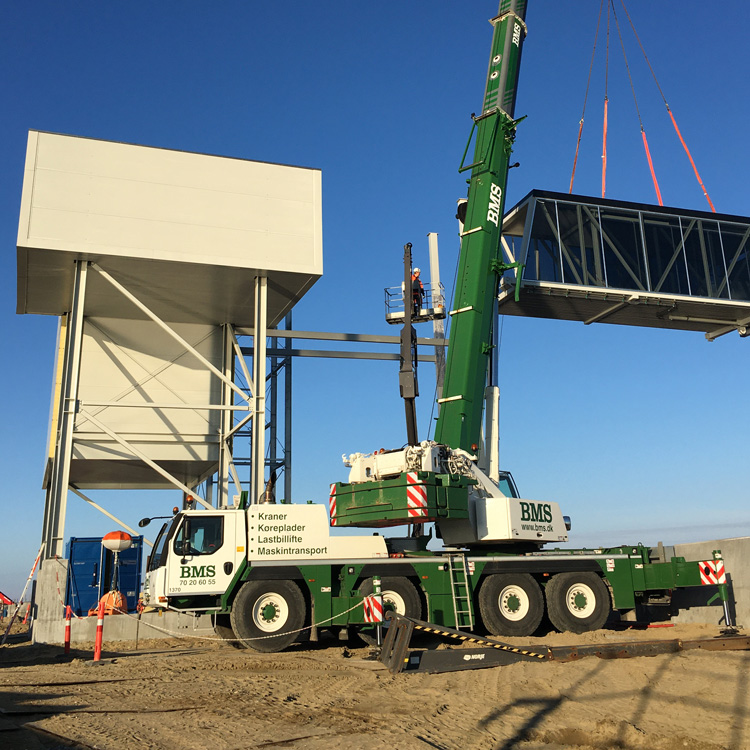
[479,573,544,636]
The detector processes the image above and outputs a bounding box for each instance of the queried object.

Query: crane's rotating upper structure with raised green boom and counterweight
[331,0,568,548]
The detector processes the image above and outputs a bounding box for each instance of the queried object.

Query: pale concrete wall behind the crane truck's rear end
[672,536,750,627]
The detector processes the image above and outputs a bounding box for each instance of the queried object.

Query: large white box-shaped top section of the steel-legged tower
[18,131,323,325]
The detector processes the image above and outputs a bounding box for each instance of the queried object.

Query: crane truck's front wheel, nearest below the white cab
[230,581,307,653]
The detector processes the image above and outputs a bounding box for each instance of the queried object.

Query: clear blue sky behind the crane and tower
[0,0,750,596]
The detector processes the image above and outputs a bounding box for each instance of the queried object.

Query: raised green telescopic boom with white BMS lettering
[435,0,526,452]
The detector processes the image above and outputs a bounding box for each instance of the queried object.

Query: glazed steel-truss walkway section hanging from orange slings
[499,190,750,340]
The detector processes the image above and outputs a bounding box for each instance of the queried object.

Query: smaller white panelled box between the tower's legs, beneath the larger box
[71,318,223,488]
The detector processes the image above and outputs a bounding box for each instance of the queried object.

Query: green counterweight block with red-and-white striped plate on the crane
[331,471,475,528]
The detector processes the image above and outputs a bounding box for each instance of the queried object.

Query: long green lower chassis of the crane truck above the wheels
[203,540,728,628]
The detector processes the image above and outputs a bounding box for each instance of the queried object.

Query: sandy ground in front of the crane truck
[0,625,750,750]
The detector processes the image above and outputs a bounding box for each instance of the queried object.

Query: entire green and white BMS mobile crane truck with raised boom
[144,0,729,652]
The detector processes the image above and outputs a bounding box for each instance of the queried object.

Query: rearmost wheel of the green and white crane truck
[544,573,612,633]
